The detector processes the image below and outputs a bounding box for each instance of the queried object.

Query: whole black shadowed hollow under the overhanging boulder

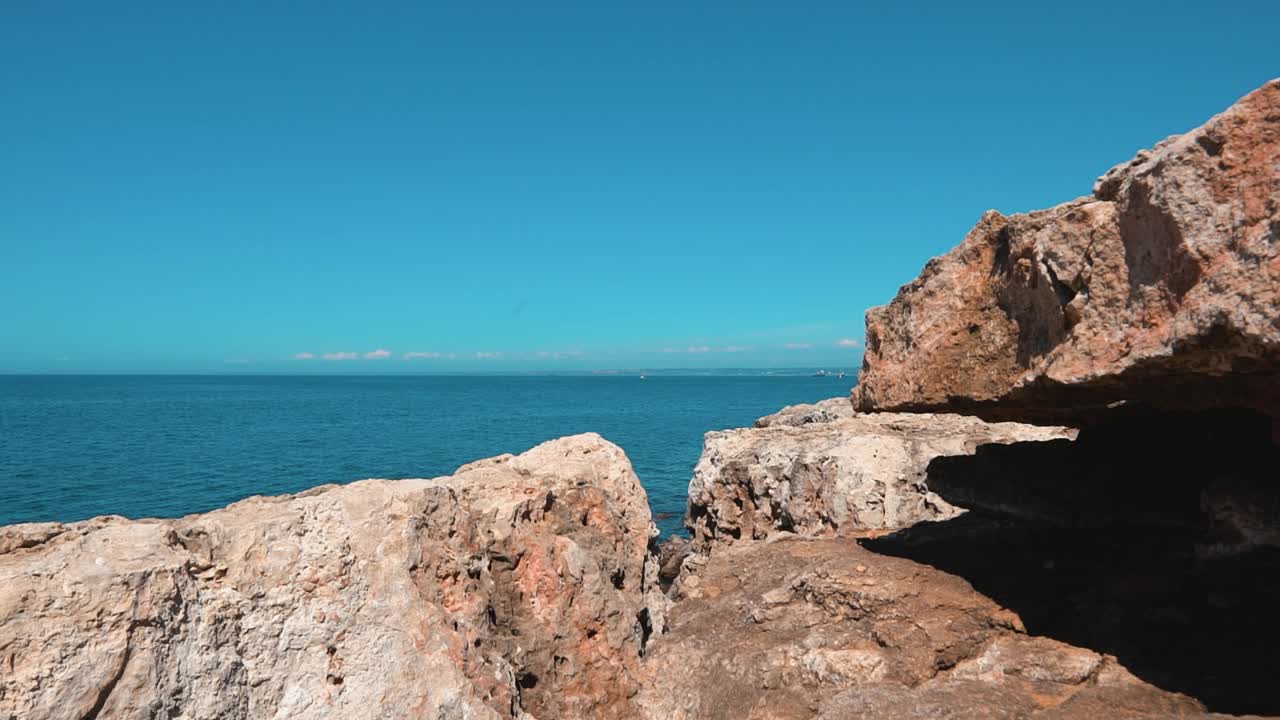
[863,410,1280,715]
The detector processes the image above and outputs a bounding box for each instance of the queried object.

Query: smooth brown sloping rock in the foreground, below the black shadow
[637,538,1206,720]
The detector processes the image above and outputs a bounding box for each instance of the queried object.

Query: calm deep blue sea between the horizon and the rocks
[0,373,851,533]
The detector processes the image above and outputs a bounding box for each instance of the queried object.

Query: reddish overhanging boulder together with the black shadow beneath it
[834,81,1280,714]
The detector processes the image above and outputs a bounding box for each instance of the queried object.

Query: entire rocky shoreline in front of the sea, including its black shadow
[0,81,1280,720]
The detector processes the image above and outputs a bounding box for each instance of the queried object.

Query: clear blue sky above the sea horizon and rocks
[0,0,1280,373]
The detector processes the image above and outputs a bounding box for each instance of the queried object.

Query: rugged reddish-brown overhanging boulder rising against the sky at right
[854,81,1280,424]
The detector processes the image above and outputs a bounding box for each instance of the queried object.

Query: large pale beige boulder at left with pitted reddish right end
[0,434,667,720]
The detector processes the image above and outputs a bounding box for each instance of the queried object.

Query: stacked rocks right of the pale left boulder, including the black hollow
[660,81,1280,719]
